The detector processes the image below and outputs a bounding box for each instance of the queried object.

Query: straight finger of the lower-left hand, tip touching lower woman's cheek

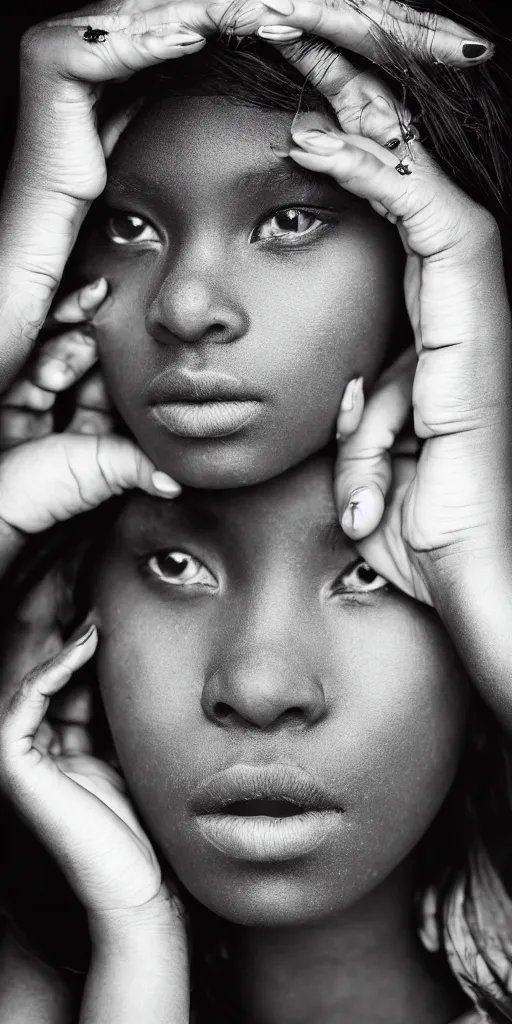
[0,626,97,766]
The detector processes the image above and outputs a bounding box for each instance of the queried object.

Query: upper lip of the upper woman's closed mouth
[150,370,260,406]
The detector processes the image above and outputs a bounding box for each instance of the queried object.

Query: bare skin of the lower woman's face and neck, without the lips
[94,456,468,1024]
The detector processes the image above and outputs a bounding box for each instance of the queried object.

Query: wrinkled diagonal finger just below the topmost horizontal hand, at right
[268,42,411,147]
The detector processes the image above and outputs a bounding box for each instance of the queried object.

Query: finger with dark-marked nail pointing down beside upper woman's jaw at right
[335,347,417,540]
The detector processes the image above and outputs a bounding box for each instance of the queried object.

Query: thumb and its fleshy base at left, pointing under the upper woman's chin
[0,434,181,536]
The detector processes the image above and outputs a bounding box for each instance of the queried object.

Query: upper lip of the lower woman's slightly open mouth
[193,764,341,814]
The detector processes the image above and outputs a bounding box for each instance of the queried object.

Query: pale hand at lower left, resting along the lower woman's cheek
[0,626,175,927]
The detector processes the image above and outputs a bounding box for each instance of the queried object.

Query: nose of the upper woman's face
[145,250,249,345]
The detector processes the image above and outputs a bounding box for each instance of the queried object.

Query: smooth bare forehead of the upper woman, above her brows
[109,96,340,205]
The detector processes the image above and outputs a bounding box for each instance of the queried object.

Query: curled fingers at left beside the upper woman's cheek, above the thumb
[0,279,115,450]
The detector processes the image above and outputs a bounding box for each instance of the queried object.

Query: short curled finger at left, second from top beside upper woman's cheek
[28,328,97,397]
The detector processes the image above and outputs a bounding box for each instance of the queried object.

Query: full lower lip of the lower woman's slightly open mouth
[198,811,341,863]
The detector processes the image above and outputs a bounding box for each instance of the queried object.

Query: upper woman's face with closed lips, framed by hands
[76,97,402,487]
